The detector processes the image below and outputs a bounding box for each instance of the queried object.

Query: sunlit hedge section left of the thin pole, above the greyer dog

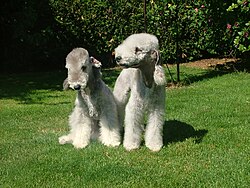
[50,0,143,66]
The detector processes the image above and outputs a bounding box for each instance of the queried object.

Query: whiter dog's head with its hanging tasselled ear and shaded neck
[115,33,164,88]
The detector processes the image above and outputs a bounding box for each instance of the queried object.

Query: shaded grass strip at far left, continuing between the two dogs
[0,69,120,104]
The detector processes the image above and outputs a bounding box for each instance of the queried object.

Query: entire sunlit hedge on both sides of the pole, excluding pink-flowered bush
[50,0,236,62]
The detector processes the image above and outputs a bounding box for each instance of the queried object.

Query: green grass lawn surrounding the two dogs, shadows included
[0,67,250,188]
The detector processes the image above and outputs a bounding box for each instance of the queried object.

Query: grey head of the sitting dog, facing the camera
[63,48,101,90]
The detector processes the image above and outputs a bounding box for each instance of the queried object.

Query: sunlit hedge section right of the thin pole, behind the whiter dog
[148,0,232,61]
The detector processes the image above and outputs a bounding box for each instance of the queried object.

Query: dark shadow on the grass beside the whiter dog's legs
[163,120,208,146]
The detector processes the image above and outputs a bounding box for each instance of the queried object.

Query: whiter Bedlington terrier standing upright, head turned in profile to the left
[113,33,166,151]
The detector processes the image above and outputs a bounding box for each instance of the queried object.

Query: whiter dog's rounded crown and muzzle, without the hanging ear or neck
[115,33,159,68]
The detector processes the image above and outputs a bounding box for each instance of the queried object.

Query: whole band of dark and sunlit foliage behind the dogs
[0,0,250,72]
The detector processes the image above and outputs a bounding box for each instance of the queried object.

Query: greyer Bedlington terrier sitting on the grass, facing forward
[59,48,121,148]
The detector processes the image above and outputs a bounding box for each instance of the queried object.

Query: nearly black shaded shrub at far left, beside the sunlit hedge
[0,0,65,72]
